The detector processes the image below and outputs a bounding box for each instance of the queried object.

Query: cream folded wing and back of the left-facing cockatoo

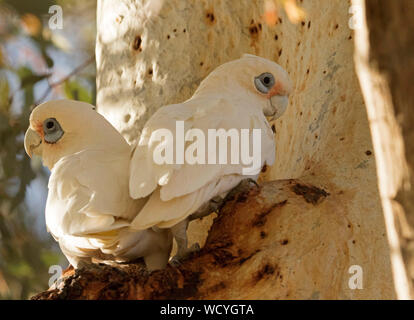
[46,150,134,238]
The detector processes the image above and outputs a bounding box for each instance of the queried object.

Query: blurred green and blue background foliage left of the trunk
[0,0,96,299]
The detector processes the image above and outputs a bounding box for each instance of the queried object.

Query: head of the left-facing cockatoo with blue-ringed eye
[24,100,127,169]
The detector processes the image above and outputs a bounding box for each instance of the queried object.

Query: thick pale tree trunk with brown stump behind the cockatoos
[37,0,395,299]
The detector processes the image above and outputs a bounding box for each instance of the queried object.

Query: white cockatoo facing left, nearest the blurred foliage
[24,100,172,270]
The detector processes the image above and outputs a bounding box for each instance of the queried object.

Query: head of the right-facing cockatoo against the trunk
[198,54,293,120]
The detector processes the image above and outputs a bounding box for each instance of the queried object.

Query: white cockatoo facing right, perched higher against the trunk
[129,54,292,262]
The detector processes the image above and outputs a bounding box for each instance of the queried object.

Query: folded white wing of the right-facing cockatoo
[130,97,275,229]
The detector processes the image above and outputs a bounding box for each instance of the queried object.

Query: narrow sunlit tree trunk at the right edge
[354,0,414,299]
